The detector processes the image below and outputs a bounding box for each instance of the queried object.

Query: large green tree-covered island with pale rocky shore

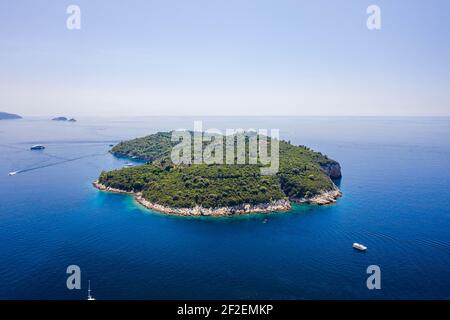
[93,132,342,216]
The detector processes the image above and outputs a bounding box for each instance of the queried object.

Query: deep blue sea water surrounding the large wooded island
[0,117,450,299]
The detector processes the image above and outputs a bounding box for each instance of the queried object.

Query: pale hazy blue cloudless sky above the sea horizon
[0,0,450,116]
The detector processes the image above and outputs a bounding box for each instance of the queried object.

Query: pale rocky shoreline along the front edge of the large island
[92,181,342,216]
